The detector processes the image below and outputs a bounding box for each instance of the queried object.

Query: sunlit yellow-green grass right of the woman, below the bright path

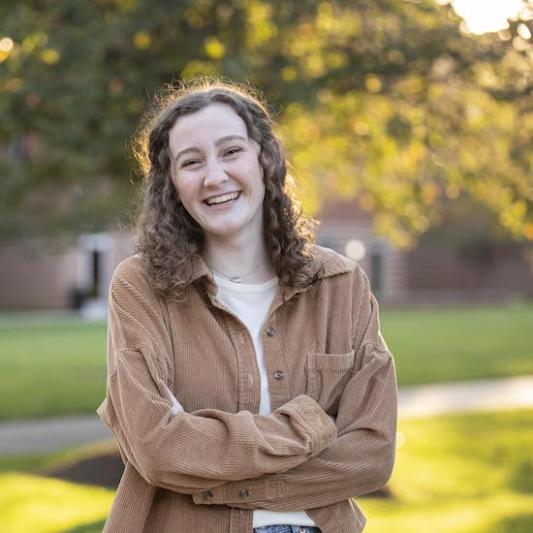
[358,409,533,533]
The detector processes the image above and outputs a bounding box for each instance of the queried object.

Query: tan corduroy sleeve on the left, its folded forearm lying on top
[97,256,336,494]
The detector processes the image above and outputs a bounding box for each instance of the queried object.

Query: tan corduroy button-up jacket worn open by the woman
[97,246,397,533]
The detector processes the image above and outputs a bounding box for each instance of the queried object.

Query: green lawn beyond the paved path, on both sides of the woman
[0,304,533,420]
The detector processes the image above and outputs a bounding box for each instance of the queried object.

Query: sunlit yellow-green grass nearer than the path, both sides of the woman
[0,409,533,533]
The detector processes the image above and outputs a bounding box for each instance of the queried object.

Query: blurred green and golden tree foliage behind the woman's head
[0,0,533,246]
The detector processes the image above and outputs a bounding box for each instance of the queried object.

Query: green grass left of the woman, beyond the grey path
[0,315,106,419]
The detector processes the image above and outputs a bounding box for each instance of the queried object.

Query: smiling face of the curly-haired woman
[169,103,265,242]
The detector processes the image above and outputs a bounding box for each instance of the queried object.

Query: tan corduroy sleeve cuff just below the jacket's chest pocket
[275,394,337,457]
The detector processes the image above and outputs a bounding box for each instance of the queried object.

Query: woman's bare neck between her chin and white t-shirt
[203,232,276,283]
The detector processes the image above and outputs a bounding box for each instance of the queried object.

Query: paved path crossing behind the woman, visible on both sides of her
[0,376,533,455]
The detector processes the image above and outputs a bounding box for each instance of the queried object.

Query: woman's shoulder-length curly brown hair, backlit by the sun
[133,78,323,300]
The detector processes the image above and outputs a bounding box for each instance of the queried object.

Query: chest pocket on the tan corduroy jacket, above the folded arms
[305,350,355,415]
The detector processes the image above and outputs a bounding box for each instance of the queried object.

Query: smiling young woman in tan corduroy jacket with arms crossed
[98,76,397,533]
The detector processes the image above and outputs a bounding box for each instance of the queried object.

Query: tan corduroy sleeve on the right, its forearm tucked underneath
[193,267,397,511]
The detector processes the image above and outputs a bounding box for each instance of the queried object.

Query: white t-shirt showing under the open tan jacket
[214,274,316,527]
